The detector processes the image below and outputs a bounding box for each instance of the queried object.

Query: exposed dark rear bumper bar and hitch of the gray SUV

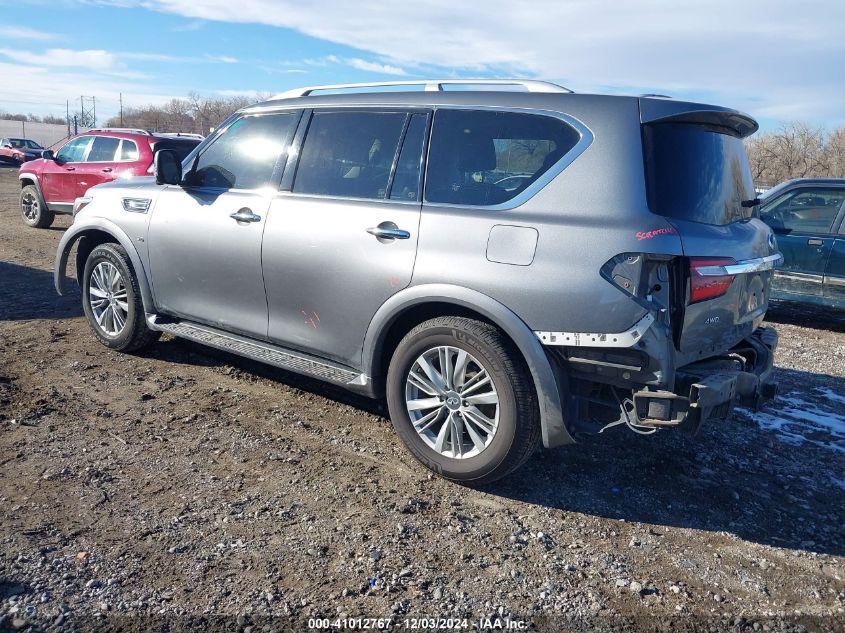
[631,327,778,432]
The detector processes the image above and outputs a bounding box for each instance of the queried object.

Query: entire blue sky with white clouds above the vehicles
[0,0,845,128]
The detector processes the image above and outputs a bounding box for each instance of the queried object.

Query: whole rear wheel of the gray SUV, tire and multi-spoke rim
[387,317,540,485]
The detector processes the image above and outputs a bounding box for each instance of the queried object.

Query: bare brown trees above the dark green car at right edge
[745,122,845,187]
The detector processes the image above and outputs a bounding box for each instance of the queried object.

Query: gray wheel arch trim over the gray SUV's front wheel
[53,218,154,313]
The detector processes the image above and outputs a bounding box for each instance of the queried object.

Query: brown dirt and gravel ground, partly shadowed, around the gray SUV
[0,169,845,632]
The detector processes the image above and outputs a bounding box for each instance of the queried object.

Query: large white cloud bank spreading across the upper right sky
[115,0,845,123]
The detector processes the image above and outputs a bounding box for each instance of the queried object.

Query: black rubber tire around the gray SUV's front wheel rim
[82,244,161,352]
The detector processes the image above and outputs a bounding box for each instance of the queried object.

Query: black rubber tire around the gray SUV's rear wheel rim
[386,316,540,485]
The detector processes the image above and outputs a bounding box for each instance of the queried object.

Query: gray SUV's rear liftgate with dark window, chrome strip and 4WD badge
[643,113,779,362]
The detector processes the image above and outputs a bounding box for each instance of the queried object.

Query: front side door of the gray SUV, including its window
[148,111,299,338]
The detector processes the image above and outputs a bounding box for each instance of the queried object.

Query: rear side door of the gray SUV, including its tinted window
[263,110,428,367]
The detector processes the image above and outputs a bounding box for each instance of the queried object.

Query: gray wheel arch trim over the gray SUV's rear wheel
[362,284,574,447]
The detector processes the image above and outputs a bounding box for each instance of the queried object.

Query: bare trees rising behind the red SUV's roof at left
[106,92,269,135]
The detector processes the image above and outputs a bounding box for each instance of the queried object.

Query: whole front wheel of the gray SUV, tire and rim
[82,244,161,352]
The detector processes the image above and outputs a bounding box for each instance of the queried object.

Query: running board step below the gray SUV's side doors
[147,314,370,391]
